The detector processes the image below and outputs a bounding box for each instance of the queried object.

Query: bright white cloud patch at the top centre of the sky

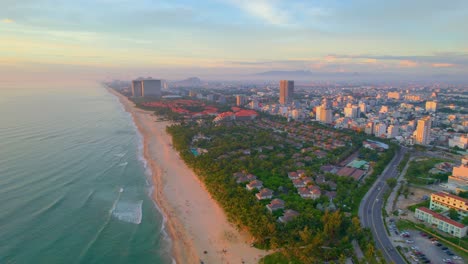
[230,0,290,25]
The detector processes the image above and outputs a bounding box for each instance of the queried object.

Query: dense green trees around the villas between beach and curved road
[167,118,395,263]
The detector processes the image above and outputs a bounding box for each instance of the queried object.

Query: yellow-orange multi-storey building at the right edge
[430,192,468,217]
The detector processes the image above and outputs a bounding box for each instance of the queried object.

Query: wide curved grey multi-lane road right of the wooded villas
[359,147,408,264]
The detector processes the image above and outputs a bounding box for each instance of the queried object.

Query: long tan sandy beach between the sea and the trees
[109,89,267,264]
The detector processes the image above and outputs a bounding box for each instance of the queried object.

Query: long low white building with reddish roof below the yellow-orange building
[415,207,468,238]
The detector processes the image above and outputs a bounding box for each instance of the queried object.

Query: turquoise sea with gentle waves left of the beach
[0,85,172,263]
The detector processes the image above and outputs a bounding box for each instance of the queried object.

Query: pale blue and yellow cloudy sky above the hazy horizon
[0,0,468,82]
